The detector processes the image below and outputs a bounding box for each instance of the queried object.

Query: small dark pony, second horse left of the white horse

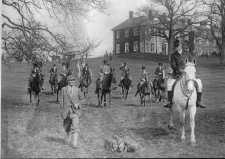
[135,82,151,106]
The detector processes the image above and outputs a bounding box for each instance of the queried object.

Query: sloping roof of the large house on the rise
[112,16,150,31]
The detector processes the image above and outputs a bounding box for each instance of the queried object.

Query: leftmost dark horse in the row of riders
[28,73,42,105]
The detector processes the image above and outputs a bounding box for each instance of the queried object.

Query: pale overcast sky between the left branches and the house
[85,0,146,56]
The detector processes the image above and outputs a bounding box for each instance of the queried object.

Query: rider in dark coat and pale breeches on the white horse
[164,39,205,108]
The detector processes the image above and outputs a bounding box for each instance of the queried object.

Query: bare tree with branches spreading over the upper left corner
[2,0,105,62]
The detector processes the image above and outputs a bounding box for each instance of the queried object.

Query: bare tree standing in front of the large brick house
[136,0,199,59]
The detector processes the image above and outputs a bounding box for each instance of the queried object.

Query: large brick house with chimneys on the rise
[112,11,168,55]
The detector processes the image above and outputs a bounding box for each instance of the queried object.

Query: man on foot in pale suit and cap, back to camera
[60,75,82,148]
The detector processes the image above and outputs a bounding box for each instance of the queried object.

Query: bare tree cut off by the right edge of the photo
[202,0,225,64]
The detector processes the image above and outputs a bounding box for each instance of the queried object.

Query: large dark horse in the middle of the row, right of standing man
[95,71,116,106]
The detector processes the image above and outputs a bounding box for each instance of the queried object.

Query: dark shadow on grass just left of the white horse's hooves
[130,127,169,140]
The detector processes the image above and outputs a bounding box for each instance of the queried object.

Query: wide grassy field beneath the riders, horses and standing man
[1,57,225,158]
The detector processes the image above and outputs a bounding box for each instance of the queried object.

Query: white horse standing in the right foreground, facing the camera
[169,60,197,145]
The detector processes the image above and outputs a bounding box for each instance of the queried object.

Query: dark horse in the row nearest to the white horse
[152,78,166,102]
